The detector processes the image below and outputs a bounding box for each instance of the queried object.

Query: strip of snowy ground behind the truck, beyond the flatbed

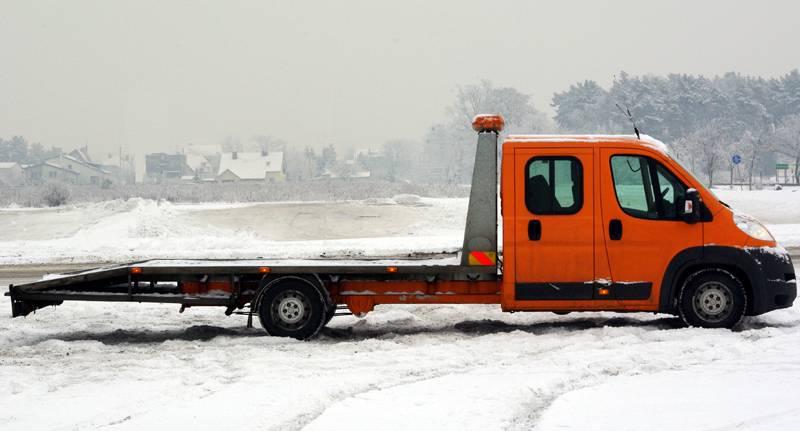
[0,188,800,265]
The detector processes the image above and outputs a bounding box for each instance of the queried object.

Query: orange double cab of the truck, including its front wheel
[501,130,796,327]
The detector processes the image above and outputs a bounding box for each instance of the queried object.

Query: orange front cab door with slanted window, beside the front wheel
[599,148,703,309]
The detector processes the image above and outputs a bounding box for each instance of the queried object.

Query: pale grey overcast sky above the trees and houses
[0,0,800,159]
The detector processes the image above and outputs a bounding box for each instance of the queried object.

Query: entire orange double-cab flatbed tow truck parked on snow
[6,115,797,339]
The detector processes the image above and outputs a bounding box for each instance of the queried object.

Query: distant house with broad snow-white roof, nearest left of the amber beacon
[217,151,286,182]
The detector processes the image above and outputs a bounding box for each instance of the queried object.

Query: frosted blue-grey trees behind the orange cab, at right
[553,70,800,185]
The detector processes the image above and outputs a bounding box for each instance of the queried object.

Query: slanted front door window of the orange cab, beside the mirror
[611,155,686,220]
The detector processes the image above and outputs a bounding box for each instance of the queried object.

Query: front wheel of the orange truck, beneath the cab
[678,268,747,329]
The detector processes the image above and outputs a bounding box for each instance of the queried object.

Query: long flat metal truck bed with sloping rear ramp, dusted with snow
[6,254,497,316]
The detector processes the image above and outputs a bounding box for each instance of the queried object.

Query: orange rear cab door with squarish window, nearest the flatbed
[513,148,594,309]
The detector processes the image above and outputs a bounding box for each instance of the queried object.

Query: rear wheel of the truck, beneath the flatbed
[258,278,328,340]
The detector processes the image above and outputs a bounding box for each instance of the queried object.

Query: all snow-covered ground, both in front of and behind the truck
[0,189,800,431]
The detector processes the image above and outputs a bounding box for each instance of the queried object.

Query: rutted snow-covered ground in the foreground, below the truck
[0,274,800,430]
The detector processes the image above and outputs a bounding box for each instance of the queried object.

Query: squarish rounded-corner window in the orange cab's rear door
[525,157,583,215]
